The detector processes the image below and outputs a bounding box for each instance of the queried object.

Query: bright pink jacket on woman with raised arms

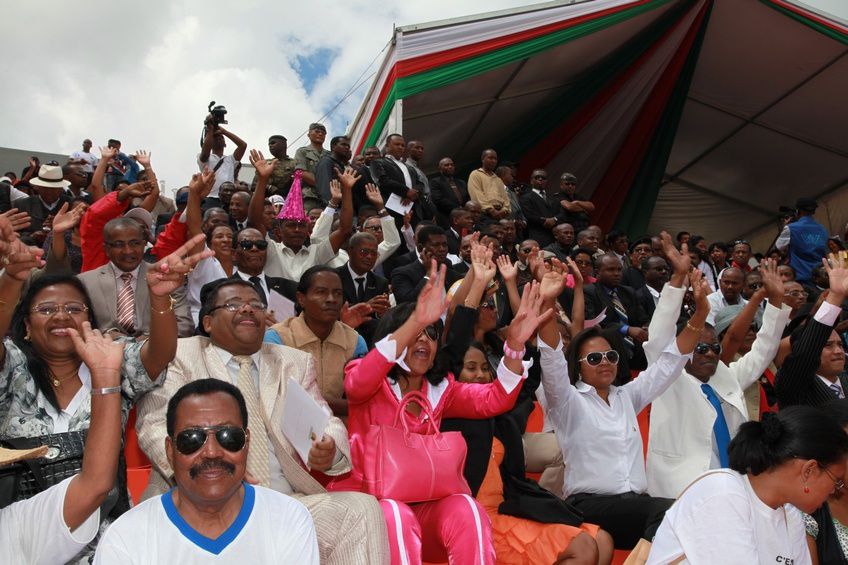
[344,337,529,488]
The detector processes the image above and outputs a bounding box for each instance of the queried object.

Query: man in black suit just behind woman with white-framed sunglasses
[585,253,650,370]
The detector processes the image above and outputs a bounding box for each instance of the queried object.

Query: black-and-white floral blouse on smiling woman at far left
[0,337,165,438]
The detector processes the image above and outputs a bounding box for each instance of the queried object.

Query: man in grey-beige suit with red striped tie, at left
[79,218,194,337]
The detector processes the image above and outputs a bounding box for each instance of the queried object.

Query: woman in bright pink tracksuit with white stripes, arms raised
[338,261,553,565]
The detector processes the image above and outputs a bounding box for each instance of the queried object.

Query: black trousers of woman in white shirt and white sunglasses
[565,492,674,549]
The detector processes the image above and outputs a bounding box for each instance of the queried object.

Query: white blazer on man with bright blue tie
[645,289,790,498]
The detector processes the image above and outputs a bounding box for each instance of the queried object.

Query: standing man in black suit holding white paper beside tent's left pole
[371,133,433,231]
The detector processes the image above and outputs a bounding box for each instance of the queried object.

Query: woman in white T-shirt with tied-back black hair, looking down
[647,406,848,565]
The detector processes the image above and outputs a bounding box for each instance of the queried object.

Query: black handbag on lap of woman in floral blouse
[0,430,130,518]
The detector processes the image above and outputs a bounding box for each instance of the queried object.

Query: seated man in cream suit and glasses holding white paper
[136,279,388,565]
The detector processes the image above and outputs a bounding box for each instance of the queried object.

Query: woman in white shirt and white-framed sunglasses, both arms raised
[539,238,709,549]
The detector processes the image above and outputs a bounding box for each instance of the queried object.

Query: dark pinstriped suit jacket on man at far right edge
[774,318,848,409]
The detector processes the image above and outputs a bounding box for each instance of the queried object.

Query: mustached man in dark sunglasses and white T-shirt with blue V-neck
[95,379,319,565]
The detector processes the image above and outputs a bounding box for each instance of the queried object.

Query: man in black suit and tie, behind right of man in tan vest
[336,233,390,346]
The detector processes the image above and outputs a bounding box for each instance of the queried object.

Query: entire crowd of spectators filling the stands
[0,116,848,565]
